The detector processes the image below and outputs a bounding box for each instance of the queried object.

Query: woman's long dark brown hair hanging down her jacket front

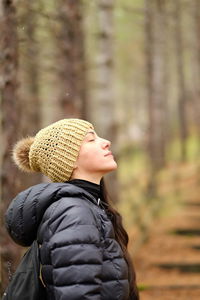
[100,178,139,300]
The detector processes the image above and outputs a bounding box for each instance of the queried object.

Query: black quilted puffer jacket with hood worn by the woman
[6,183,129,300]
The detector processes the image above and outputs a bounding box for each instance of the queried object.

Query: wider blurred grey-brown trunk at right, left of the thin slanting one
[145,0,168,174]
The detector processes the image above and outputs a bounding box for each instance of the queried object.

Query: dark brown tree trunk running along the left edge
[0,0,20,294]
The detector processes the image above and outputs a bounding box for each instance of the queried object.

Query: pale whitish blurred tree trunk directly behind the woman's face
[90,0,118,202]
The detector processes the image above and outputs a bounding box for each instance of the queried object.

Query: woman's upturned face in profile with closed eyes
[73,129,117,181]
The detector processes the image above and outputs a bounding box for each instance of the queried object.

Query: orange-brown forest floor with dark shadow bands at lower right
[134,186,200,300]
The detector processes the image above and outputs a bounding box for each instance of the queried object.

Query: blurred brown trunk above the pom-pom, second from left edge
[18,1,41,135]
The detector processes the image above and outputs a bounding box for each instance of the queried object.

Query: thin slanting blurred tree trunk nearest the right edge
[174,0,188,161]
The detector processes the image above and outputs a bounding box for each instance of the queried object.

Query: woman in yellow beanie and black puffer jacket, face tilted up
[6,119,139,300]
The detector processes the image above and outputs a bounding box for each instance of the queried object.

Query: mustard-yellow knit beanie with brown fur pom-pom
[13,119,94,182]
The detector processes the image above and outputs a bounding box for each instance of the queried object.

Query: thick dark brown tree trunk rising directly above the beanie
[56,0,88,118]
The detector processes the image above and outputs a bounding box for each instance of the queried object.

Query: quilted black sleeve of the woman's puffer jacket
[49,198,103,300]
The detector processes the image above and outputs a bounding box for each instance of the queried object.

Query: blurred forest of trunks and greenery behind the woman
[0,0,200,293]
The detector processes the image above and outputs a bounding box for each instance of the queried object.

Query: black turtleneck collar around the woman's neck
[68,179,100,200]
